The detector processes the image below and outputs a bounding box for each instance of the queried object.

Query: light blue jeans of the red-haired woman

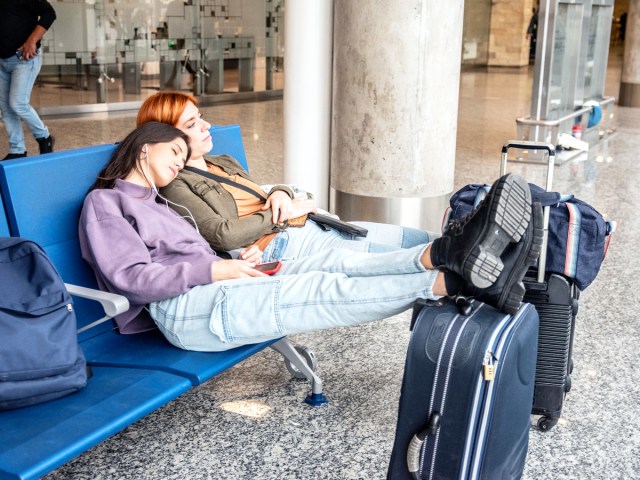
[262,222,439,262]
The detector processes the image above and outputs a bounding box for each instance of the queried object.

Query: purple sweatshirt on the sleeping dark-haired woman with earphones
[79,180,220,333]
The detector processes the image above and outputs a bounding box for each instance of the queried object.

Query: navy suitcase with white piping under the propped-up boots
[387,298,538,480]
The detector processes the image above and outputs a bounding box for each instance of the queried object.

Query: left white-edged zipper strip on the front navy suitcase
[418,304,482,480]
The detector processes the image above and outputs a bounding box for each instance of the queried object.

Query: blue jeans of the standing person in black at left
[0,51,49,153]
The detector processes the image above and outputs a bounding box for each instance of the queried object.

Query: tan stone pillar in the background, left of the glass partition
[488,0,533,67]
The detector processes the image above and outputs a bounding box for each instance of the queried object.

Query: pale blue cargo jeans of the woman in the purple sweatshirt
[149,245,439,351]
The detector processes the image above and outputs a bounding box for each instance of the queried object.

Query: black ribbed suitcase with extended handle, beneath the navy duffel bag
[500,141,580,431]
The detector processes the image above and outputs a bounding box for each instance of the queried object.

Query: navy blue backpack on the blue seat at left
[0,237,87,410]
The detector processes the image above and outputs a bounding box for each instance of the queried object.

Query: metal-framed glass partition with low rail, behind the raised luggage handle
[516,0,613,150]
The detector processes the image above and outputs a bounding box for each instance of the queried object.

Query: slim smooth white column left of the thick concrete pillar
[283,0,333,209]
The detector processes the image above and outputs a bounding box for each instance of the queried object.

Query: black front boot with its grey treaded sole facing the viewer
[431,173,531,288]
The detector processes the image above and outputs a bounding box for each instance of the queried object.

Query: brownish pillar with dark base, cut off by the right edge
[618,0,640,107]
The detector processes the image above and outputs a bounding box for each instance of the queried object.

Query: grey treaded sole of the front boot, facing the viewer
[464,174,531,288]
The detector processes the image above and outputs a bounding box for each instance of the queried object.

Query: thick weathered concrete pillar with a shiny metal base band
[330,0,463,230]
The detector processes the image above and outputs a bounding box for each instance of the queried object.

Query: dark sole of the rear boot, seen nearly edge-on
[498,204,544,315]
